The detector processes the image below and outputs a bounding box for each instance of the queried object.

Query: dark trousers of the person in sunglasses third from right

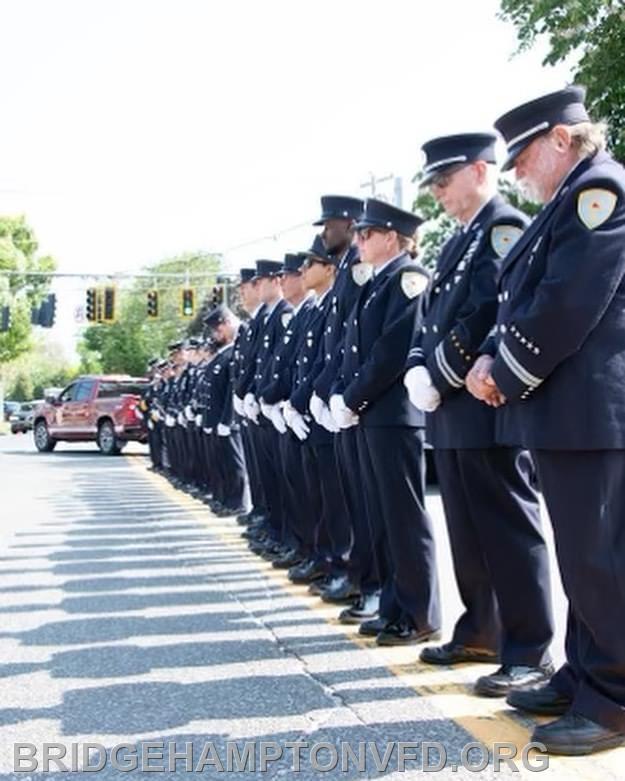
[359,426,441,631]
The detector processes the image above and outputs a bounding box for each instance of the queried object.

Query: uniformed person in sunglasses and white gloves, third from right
[330,198,440,645]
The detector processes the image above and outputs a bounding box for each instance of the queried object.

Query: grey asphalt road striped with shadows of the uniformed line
[0,435,625,780]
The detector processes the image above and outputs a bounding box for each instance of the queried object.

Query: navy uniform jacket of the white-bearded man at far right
[492,152,625,450]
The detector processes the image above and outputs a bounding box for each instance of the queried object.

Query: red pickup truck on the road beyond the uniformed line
[33,374,147,456]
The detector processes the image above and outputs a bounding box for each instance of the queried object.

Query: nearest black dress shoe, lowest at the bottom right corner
[531,710,625,756]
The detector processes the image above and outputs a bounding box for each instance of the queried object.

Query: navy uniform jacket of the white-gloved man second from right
[408,195,529,448]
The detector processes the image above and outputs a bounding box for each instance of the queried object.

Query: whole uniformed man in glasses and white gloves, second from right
[405,133,553,697]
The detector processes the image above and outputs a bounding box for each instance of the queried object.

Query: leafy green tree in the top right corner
[500,0,625,162]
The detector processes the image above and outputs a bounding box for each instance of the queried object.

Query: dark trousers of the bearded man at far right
[532,450,625,732]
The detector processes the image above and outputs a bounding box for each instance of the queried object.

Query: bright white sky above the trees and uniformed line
[0,0,568,350]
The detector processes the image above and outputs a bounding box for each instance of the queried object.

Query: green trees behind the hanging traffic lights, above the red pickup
[78,252,221,376]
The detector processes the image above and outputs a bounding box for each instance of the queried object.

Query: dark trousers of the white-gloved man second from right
[434,447,553,666]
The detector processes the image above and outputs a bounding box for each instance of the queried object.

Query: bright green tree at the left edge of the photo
[0,215,56,364]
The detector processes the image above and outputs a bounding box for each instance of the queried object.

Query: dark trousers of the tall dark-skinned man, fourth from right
[334,426,381,594]
